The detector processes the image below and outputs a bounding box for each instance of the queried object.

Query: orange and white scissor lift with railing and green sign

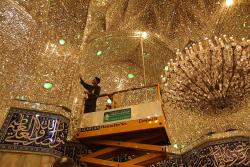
[76,85,170,167]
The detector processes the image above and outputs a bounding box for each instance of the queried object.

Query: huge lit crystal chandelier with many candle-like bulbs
[162,35,250,110]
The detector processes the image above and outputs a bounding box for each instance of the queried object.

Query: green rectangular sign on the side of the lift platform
[103,108,131,122]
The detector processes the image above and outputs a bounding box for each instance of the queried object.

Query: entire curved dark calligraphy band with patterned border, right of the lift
[148,138,250,167]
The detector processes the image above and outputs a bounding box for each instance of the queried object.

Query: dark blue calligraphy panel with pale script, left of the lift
[0,108,69,155]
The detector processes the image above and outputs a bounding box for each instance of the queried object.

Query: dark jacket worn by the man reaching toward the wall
[80,79,101,107]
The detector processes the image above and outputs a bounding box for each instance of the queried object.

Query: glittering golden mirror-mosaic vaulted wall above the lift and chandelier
[0,0,250,140]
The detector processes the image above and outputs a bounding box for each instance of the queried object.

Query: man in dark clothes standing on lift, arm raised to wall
[80,77,101,113]
